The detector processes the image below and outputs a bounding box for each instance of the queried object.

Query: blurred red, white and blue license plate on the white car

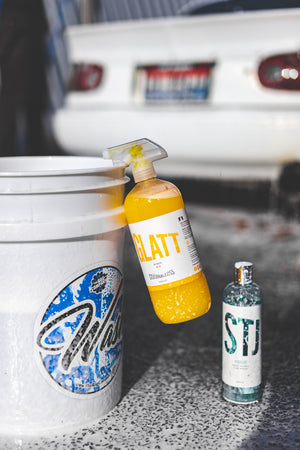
[135,63,213,103]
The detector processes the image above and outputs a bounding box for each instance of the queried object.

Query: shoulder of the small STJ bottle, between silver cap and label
[223,282,263,306]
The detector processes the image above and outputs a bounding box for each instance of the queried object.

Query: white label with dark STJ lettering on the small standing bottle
[222,303,261,388]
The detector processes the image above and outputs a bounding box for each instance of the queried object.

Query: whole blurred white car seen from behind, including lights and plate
[54,3,300,178]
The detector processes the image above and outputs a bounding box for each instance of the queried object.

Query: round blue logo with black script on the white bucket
[35,266,122,394]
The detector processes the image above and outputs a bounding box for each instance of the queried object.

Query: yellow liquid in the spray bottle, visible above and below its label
[124,178,211,324]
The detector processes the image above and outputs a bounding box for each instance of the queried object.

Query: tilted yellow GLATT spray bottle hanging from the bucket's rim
[104,139,211,324]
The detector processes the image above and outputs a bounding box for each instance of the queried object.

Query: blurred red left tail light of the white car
[70,64,103,91]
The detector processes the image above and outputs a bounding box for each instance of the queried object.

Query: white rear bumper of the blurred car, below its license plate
[54,107,300,179]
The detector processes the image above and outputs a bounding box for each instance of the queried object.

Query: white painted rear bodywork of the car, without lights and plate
[54,8,300,178]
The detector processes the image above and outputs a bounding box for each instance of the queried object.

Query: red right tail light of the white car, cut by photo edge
[258,53,300,91]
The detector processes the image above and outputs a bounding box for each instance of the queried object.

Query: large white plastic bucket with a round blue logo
[0,156,128,434]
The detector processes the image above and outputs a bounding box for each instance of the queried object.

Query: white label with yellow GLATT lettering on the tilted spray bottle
[129,208,202,289]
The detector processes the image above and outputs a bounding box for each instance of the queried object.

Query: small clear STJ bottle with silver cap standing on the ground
[222,261,263,404]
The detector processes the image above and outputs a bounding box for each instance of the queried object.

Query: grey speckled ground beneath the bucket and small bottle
[0,205,300,450]
